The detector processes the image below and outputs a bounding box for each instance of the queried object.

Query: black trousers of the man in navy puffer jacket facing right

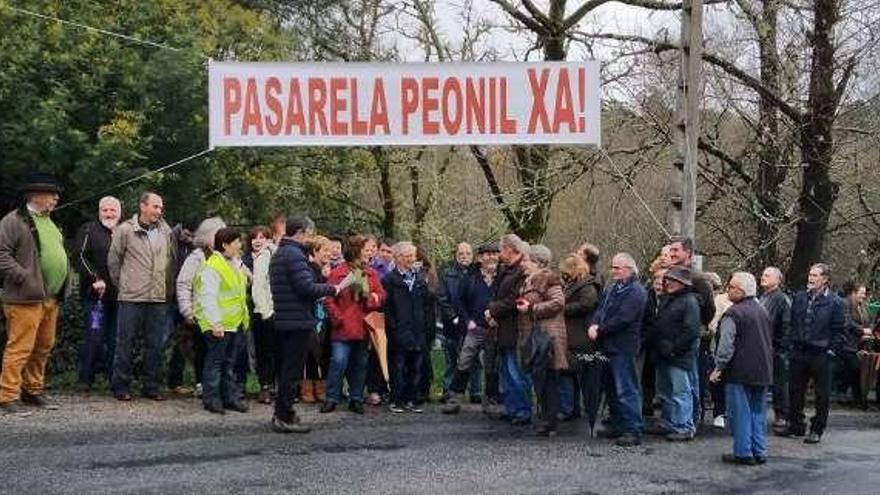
[275,331,313,422]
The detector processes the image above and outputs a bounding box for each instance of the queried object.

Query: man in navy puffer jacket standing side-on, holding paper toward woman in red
[269,217,339,433]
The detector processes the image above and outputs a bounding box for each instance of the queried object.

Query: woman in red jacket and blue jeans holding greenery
[321,235,385,414]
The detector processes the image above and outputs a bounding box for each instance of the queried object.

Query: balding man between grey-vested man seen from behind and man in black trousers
[760,266,791,428]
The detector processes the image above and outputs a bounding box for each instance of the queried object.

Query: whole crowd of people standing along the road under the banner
[0,174,874,465]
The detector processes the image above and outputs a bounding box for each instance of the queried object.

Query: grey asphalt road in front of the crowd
[0,396,880,495]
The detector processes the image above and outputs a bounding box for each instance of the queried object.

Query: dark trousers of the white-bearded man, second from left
[79,296,116,385]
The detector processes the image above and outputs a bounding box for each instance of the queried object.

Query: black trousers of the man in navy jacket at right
[788,350,831,435]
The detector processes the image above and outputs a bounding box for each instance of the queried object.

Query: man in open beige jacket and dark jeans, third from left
[107,192,177,402]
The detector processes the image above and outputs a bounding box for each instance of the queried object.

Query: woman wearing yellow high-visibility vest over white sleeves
[193,228,250,414]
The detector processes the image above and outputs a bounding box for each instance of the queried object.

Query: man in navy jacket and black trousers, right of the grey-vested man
[776,263,846,444]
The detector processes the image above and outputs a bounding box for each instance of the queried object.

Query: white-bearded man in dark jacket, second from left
[73,196,122,391]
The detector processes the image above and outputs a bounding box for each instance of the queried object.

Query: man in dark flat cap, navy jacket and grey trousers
[442,244,499,414]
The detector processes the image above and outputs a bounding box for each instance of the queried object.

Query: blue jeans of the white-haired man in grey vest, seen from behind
[724,383,769,457]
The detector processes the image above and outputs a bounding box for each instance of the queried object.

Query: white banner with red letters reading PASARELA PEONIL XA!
[209,61,601,147]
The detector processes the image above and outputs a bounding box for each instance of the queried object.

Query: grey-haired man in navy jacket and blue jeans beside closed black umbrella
[587,253,647,447]
